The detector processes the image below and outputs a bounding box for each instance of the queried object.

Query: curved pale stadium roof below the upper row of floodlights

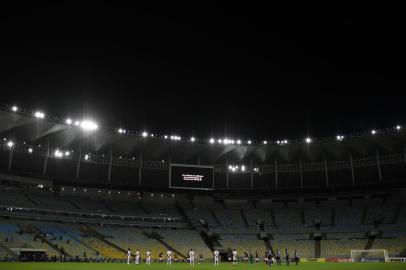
[0,105,406,164]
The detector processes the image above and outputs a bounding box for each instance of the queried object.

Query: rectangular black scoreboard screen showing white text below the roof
[169,163,214,190]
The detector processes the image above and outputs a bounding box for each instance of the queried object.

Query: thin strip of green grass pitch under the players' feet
[0,263,406,270]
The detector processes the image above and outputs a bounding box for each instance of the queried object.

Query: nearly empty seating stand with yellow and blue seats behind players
[0,185,406,260]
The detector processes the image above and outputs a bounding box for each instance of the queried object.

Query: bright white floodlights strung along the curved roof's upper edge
[10,106,402,144]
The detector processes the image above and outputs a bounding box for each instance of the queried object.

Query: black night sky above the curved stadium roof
[0,1,406,139]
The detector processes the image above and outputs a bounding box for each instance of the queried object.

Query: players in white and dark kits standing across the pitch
[127,249,299,266]
